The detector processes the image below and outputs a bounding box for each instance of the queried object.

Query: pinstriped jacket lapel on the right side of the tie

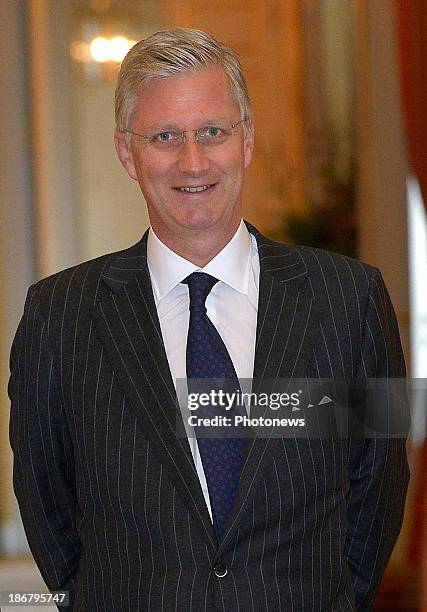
[218,224,318,555]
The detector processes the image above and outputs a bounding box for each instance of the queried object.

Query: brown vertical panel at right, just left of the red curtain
[353,0,410,364]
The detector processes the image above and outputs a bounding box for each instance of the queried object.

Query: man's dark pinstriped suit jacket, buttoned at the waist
[9,226,408,612]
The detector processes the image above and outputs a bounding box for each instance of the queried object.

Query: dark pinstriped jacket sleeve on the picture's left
[9,286,80,610]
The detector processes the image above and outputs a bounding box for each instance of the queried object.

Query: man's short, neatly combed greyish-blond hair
[115,28,252,131]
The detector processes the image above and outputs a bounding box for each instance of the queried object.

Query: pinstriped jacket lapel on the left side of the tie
[90,233,215,548]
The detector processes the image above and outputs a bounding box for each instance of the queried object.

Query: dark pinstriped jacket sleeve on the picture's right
[346,268,409,612]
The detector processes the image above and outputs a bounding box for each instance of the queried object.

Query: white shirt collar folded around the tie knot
[147,221,252,300]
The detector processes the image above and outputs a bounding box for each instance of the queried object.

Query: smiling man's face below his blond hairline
[116,66,253,248]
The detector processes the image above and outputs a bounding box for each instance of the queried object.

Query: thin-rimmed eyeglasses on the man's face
[122,119,247,151]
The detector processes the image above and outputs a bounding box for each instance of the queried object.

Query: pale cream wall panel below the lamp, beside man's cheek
[74,82,149,260]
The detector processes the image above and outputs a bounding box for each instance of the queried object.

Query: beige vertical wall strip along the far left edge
[0,0,35,550]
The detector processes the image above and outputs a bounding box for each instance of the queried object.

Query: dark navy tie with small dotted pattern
[182,272,247,540]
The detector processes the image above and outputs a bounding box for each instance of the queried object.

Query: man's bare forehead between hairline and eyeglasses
[132,66,239,128]
